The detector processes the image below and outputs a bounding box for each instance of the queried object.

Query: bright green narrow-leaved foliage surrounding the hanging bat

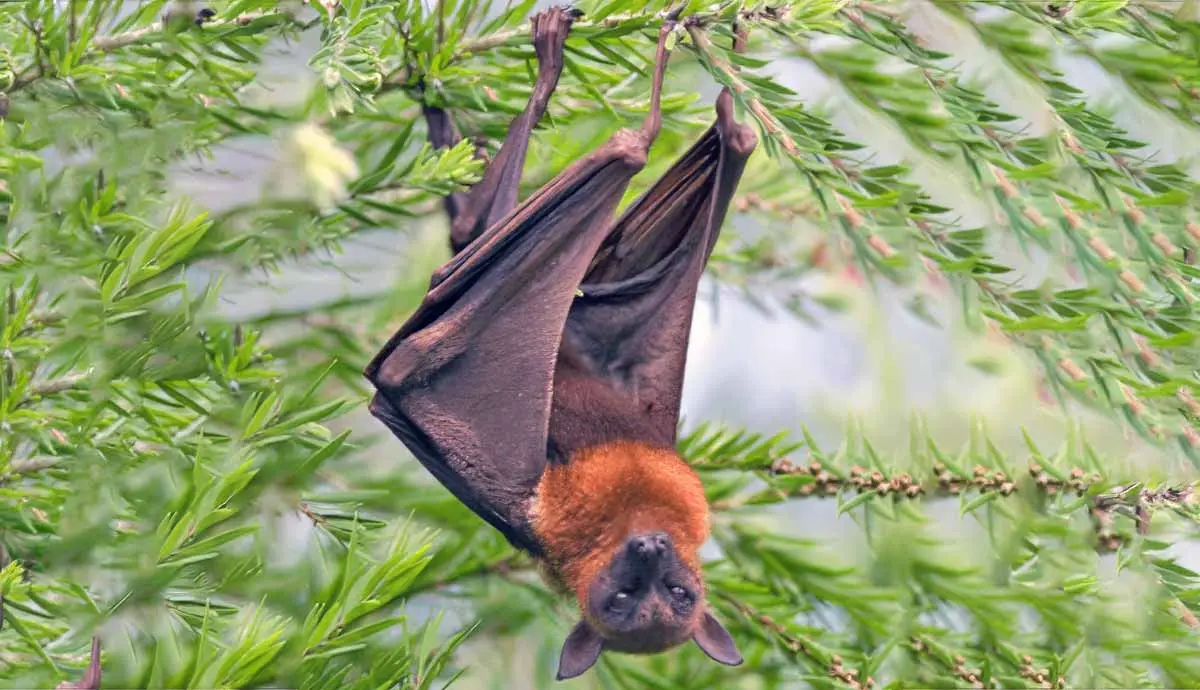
[0,0,1200,689]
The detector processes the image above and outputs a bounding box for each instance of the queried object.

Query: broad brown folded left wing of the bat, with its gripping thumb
[365,18,670,554]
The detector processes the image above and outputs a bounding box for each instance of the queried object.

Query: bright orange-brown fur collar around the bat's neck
[532,440,708,602]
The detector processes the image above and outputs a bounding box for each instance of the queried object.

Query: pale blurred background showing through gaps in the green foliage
[7,0,1200,688]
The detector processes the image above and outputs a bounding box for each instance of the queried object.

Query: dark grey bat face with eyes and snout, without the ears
[583,532,704,654]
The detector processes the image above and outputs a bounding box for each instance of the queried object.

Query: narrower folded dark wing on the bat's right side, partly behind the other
[564,92,757,444]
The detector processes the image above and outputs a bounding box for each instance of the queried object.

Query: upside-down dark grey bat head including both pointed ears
[558,532,742,680]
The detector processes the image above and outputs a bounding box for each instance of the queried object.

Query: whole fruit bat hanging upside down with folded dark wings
[366,8,757,679]
